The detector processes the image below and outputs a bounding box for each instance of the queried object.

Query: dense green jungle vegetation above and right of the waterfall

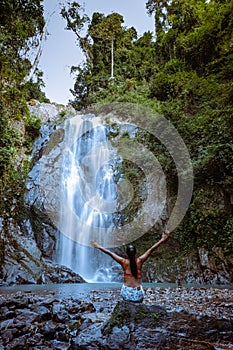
[61,0,233,253]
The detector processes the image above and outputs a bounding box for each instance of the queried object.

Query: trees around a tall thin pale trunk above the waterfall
[62,2,151,109]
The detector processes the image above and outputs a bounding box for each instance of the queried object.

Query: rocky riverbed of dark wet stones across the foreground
[0,286,233,350]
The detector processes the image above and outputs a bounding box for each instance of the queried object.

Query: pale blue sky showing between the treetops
[38,0,154,105]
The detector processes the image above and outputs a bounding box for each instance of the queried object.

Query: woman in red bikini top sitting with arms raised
[90,231,170,302]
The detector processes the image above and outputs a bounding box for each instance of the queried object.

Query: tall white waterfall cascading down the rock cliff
[57,115,117,281]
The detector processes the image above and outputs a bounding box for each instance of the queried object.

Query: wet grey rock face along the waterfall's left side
[0,101,85,285]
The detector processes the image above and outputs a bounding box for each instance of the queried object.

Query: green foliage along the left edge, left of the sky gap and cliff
[0,0,45,245]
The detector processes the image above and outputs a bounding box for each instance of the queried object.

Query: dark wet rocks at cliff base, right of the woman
[143,243,233,286]
